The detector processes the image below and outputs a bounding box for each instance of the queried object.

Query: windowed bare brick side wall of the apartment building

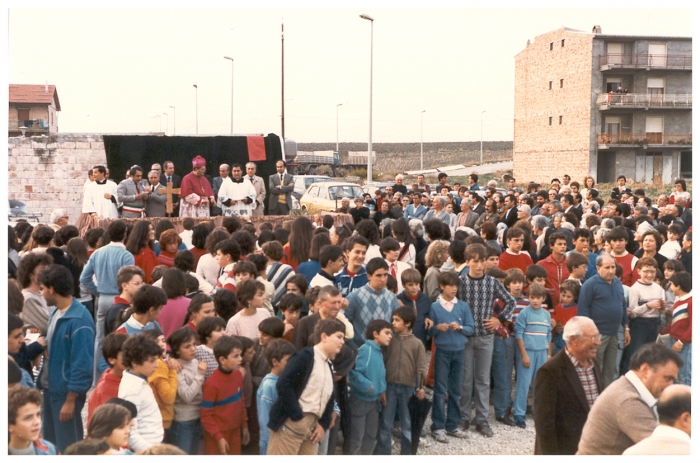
[513,28,593,185]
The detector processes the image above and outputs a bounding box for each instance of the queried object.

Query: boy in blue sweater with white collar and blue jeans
[428,272,474,444]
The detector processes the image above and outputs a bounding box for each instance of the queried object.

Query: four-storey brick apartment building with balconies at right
[513,26,692,183]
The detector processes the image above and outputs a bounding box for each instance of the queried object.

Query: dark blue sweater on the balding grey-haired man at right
[577,275,628,336]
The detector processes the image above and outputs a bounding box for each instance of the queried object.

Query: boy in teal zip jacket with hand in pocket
[350,320,391,455]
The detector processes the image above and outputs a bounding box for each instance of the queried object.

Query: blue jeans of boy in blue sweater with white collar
[430,350,464,431]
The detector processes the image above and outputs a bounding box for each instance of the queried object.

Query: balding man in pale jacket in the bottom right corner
[622,384,690,455]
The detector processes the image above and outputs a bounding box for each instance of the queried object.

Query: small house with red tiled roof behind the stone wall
[7,84,61,137]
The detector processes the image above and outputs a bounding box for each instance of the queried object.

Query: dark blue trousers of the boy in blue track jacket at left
[41,391,85,453]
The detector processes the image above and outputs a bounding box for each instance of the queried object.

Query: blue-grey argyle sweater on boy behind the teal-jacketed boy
[345,284,399,346]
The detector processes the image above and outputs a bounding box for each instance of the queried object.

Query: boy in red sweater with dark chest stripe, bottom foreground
[202,336,250,455]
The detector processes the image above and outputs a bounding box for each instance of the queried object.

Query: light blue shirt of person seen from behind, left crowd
[80,243,134,296]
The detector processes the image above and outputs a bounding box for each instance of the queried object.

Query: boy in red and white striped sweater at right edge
[667,272,693,386]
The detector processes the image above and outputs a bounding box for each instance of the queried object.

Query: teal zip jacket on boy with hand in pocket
[350,340,386,402]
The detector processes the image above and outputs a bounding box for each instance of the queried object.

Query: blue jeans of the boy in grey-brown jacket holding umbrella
[374,383,413,455]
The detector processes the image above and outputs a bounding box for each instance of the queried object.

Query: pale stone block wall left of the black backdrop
[7,133,107,223]
